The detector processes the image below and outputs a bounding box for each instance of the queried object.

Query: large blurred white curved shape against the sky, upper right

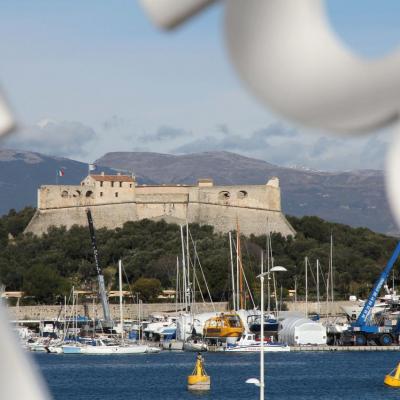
[225,0,400,132]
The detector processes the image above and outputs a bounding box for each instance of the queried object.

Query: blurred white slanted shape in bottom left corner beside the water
[0,304,50,400]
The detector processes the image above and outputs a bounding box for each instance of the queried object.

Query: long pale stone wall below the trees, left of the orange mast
[8,302,228,320]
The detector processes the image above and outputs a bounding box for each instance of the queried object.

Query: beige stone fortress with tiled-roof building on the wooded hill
[25,173,295,236]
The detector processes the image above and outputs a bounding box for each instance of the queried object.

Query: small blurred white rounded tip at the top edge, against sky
[140,0,215,29]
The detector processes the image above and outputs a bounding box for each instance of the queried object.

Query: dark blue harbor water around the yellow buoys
[34,352,400,400]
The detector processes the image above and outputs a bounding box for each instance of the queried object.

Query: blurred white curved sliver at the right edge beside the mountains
[385,124,400,231]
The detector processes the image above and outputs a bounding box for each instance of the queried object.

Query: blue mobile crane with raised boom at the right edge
[346,242,400,345]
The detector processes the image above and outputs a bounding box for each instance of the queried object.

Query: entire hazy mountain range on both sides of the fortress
[0,150,398,234]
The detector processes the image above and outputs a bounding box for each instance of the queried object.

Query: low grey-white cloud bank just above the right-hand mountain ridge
[172,124,391,171]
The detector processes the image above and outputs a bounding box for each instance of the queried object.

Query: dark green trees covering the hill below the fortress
[0,208,397,303]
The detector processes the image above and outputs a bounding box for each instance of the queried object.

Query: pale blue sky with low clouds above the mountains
[0,0,400,170]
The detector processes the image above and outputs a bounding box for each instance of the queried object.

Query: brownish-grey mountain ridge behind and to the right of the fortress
[96,152,398,234]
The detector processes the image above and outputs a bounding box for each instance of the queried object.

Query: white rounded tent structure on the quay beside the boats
[279,317,327,346]
